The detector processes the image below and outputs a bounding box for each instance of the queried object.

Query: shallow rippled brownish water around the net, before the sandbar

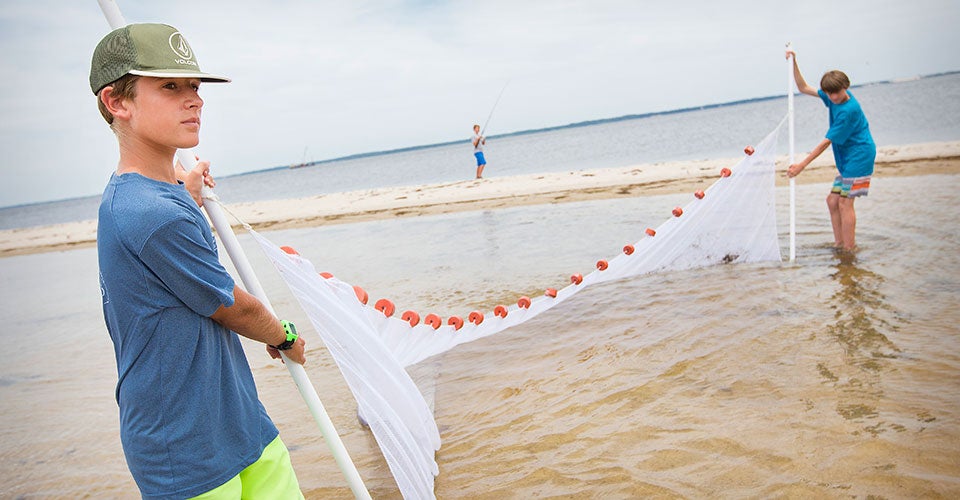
[0,175,960,498]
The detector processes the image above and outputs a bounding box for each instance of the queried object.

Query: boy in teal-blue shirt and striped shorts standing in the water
[787,50,877,252]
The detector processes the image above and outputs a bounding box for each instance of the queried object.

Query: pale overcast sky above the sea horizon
[0,0,960,206]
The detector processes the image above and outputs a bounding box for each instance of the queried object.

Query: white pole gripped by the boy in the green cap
[97,0,370,499]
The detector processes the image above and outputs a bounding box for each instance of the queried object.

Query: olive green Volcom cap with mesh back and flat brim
[90,24,230,94]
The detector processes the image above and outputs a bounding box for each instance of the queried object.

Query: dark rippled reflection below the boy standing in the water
[819,252,900,435]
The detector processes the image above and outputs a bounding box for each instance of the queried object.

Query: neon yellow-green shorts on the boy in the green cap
[191,436,303,500]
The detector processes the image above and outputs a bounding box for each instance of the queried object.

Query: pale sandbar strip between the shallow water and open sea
[0,141,960,257]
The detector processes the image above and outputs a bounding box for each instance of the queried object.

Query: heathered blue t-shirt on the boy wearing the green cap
[97,173,278,498]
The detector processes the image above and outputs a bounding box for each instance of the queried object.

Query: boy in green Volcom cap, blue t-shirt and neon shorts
[90,24,305,498]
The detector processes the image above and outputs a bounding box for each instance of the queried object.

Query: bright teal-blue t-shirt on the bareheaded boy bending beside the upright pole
[817,90,877,177]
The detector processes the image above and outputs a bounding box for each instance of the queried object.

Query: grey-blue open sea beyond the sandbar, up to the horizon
[0,73,960,229]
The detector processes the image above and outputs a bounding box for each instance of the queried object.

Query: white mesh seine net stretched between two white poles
[251,122,783,498]
